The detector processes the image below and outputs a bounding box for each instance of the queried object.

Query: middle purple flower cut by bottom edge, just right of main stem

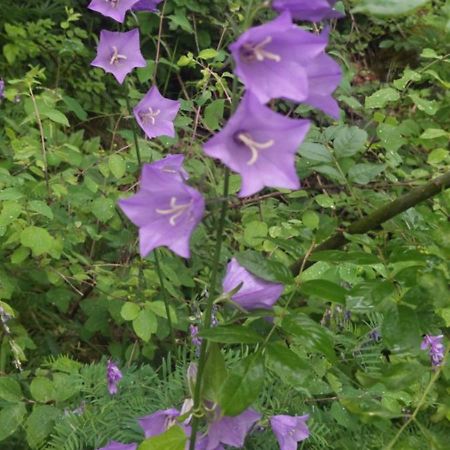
[199,409,261,450]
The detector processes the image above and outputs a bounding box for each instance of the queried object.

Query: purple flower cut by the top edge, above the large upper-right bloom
[272,0,343,22]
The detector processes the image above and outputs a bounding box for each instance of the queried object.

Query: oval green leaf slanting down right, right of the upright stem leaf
[266,343,311,387]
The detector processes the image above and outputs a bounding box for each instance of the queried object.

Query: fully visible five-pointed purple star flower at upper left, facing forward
[91,28,147,84]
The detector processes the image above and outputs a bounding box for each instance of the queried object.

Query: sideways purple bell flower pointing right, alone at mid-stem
[222,258,284,311]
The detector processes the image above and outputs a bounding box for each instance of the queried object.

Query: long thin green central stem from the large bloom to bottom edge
[189,168,230,450]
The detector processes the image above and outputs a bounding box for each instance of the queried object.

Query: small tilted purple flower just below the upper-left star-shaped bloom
[133,86,180,139]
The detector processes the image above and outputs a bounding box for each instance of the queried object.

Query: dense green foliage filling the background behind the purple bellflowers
[0,0,450,450]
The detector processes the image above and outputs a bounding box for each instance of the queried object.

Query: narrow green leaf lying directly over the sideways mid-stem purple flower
[236,250,292,284]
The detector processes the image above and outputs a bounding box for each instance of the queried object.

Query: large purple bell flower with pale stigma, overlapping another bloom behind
[230,12,328,103]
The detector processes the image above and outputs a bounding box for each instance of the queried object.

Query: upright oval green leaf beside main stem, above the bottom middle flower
[219,353,264,416]
